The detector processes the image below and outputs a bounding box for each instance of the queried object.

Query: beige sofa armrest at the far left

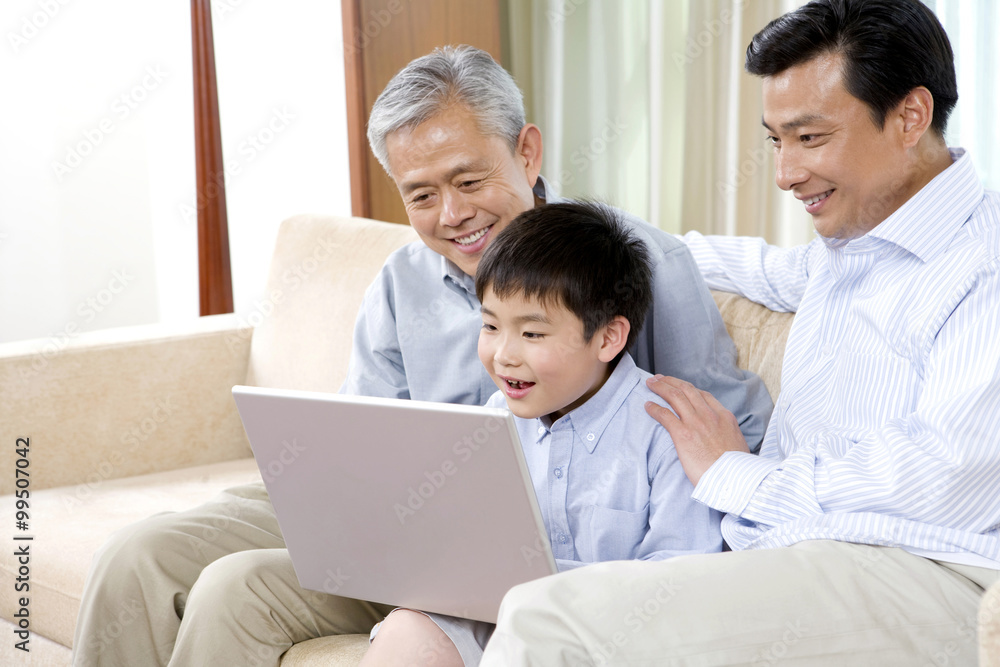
[0,315,252,494]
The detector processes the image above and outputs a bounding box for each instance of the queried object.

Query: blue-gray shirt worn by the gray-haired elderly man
[340,178,772,449]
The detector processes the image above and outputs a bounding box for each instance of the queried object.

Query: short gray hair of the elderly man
[368,46,525,176]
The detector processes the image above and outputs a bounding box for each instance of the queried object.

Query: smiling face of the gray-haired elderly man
[386,105,541,276]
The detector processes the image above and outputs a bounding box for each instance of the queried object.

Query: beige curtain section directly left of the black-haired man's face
[681,0,814,246]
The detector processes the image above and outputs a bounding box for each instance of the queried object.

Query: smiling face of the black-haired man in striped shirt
[763,53,916,240]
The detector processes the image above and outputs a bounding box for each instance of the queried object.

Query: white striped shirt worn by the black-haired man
[685,150,1000,568]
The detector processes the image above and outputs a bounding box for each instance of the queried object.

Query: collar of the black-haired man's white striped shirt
[860,148,984,262]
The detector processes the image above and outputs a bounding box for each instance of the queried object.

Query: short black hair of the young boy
[476,202,653,349]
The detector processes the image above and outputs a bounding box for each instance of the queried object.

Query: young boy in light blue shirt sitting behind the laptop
[362,203,722,665]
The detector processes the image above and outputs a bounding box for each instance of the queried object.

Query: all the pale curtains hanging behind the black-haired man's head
[507,0,1000,246]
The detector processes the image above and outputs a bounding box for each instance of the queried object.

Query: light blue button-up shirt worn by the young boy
[486,354,722,570]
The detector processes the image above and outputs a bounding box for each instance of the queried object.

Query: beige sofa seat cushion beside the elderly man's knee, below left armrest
[0,458,260,646]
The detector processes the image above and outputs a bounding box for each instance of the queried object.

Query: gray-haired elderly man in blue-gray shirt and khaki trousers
[74,47,772,666]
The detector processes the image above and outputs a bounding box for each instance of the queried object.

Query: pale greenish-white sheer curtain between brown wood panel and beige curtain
[508,0,686,227]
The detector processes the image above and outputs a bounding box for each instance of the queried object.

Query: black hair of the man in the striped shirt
[746,0,958,137]
